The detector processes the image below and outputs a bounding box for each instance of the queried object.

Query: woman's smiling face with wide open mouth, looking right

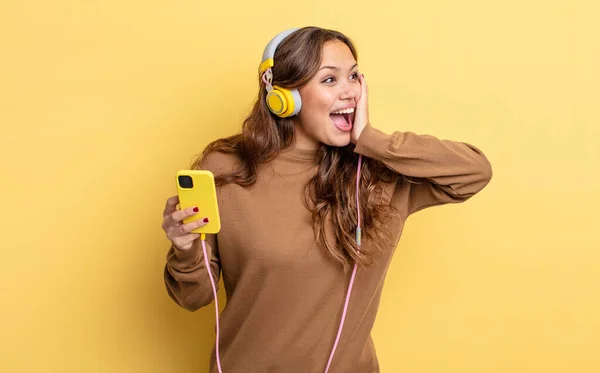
[294,40,361,149]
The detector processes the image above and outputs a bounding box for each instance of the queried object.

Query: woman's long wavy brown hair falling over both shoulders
[192,27,399,270]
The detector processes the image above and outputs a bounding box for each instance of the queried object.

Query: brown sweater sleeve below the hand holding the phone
[164,234,221,311]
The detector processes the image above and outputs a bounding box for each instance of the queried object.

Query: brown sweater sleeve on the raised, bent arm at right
[354,125,492,216]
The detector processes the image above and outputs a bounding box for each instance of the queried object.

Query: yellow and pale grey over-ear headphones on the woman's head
[260,28,302,118]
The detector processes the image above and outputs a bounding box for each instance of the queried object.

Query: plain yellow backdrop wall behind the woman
[0,0,600,373]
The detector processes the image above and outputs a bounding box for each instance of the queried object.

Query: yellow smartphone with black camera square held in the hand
[177,170,221,234]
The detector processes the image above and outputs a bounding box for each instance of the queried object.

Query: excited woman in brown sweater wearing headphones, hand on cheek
[163,27,492,373]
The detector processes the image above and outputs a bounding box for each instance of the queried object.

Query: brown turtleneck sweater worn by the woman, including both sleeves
[164,126,492,373]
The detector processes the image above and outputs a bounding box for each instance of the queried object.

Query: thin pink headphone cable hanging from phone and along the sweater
[201,154,362,373]
